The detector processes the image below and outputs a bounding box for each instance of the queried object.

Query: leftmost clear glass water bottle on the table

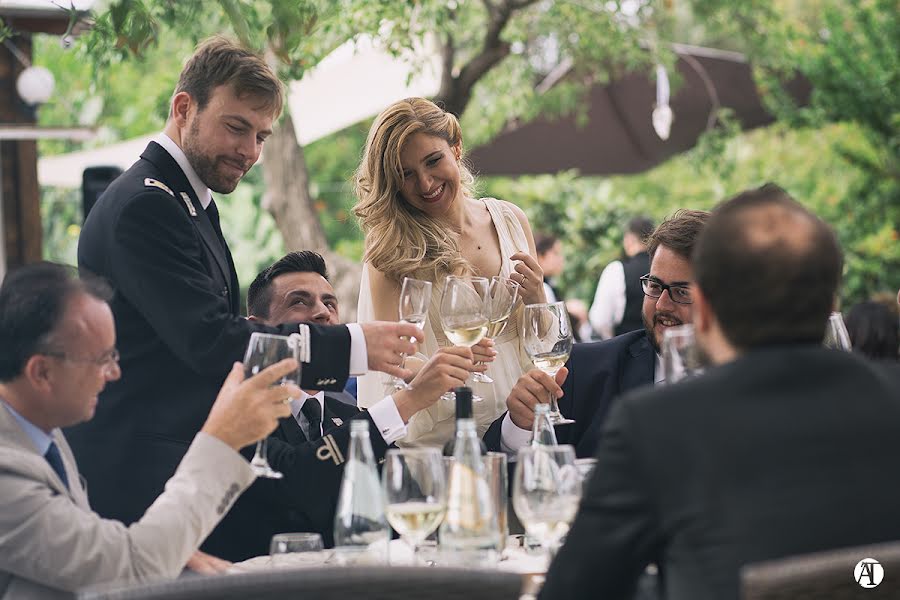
[334,419,390,564]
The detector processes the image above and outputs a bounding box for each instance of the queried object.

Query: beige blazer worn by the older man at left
[0,405,254,600]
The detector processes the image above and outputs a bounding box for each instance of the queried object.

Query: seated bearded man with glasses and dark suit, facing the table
[484,210,709,457]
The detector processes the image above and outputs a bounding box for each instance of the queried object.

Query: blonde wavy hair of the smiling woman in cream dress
[353,98,475,282]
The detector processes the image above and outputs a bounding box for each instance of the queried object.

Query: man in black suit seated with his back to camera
[540,184,900,600]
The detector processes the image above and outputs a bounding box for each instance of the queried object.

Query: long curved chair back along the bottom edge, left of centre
[78,567,522,600]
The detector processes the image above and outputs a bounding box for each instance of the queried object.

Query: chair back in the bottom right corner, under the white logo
[741,542,900,600]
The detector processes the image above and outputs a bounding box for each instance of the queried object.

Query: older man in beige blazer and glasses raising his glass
[0,263,300,599]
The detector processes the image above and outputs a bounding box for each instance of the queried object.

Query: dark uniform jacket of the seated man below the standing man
[203,394,388,561]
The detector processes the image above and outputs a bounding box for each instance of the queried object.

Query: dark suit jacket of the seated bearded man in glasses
[484,330,656,458]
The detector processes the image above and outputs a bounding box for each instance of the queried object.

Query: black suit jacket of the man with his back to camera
[540,347,900,600]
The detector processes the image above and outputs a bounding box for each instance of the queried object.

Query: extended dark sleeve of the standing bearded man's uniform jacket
[108,191,350,390]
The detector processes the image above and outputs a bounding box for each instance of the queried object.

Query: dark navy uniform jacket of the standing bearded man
[66,142,350,523]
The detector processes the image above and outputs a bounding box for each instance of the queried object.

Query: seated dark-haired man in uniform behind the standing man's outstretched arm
[203,251,474,560]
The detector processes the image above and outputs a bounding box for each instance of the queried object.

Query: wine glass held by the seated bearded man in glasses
[522,302,575,425]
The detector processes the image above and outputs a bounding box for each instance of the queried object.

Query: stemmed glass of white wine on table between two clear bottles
[381,448,447,563]
